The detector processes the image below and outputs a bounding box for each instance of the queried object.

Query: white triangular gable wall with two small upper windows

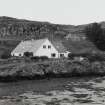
[33,40,59,58]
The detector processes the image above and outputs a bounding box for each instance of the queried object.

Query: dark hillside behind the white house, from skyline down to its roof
[0,16,105,55]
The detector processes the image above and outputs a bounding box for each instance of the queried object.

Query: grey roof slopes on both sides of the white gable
[12,38,67,53]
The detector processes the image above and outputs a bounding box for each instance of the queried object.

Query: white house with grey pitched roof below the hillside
[11,39,69,58]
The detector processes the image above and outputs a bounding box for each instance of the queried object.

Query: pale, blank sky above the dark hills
[0,0,105,25]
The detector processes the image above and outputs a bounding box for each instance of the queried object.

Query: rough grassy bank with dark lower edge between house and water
[0,57,105,81]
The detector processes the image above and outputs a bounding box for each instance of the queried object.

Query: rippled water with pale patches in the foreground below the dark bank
[0,77,105,105]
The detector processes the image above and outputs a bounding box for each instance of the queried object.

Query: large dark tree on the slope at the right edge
[85,23,105,51]
